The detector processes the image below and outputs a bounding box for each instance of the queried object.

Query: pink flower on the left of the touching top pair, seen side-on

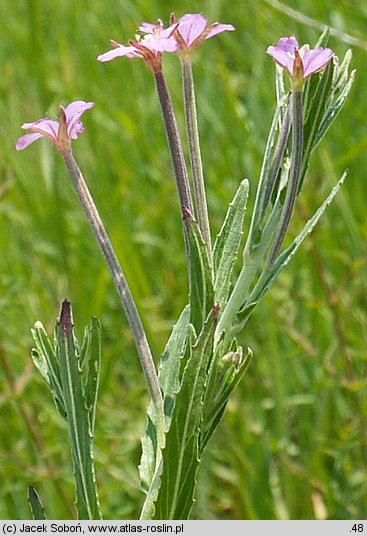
[97,19,177,71]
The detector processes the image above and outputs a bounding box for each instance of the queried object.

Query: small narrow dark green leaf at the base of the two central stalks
[185,214,214,333]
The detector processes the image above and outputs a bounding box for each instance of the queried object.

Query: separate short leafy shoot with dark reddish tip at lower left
[31,300,101,519]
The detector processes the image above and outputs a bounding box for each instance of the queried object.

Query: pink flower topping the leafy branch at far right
[267,35,334,81]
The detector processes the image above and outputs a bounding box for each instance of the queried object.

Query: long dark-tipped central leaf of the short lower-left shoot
[56,300,101,519]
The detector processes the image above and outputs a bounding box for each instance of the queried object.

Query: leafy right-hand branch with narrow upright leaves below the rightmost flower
[216,38,354,349]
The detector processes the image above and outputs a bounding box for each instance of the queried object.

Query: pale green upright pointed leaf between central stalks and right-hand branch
[213,180,249,309]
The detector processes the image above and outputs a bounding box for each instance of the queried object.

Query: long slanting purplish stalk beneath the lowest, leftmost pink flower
[64,151,164,444]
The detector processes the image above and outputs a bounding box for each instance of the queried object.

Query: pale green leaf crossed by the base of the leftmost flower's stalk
[139,305,190,506]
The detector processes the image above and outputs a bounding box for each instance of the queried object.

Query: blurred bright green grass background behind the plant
[0,0,367,519]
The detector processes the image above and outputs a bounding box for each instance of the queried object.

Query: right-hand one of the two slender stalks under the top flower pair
[182,59,212,264]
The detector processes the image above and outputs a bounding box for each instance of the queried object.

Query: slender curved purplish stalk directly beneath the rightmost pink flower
[268,90,303,265]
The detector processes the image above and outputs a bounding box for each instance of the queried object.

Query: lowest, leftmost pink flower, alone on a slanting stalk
[16,101,94,154]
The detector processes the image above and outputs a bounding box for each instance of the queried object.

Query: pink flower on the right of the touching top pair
[171,13,235,56]
